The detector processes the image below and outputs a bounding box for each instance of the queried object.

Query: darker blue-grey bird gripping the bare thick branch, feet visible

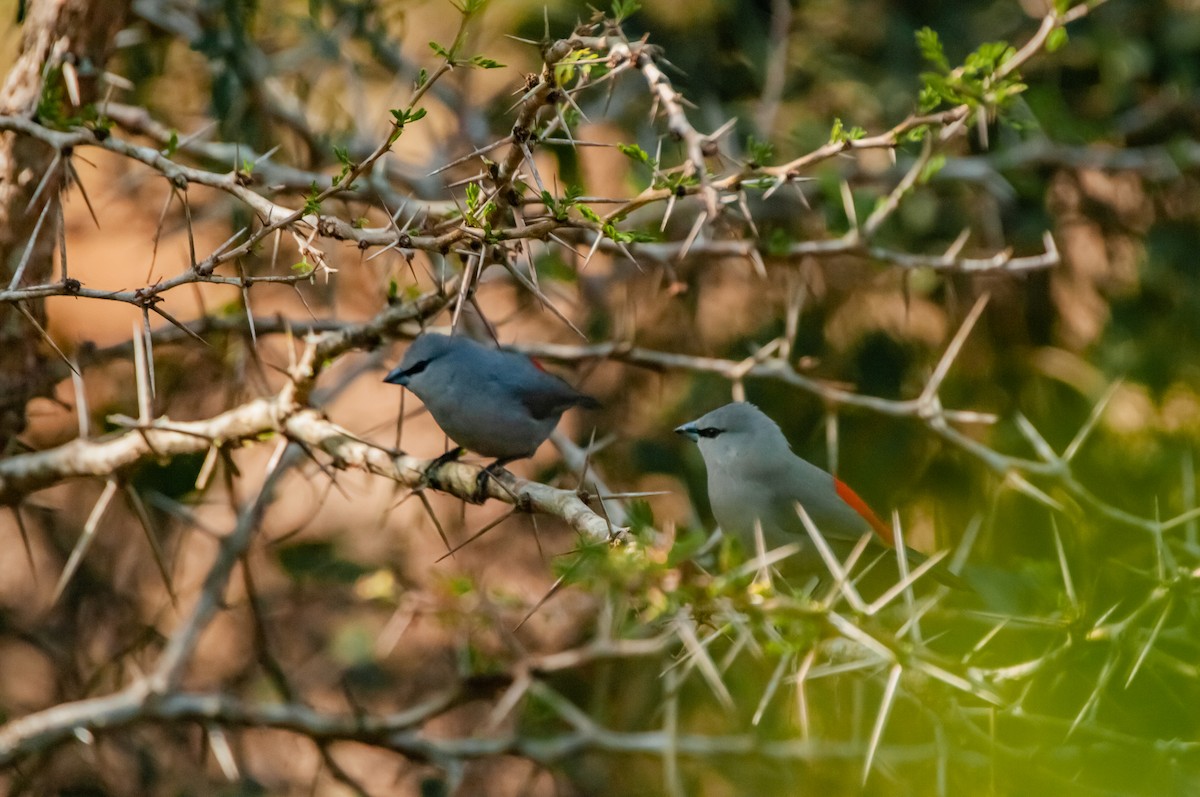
[384,332,600,492]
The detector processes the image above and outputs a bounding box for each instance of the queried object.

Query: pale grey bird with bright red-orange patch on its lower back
[674,402,961,587]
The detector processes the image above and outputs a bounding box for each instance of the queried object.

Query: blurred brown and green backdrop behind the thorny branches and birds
[0,0,1200,796]
